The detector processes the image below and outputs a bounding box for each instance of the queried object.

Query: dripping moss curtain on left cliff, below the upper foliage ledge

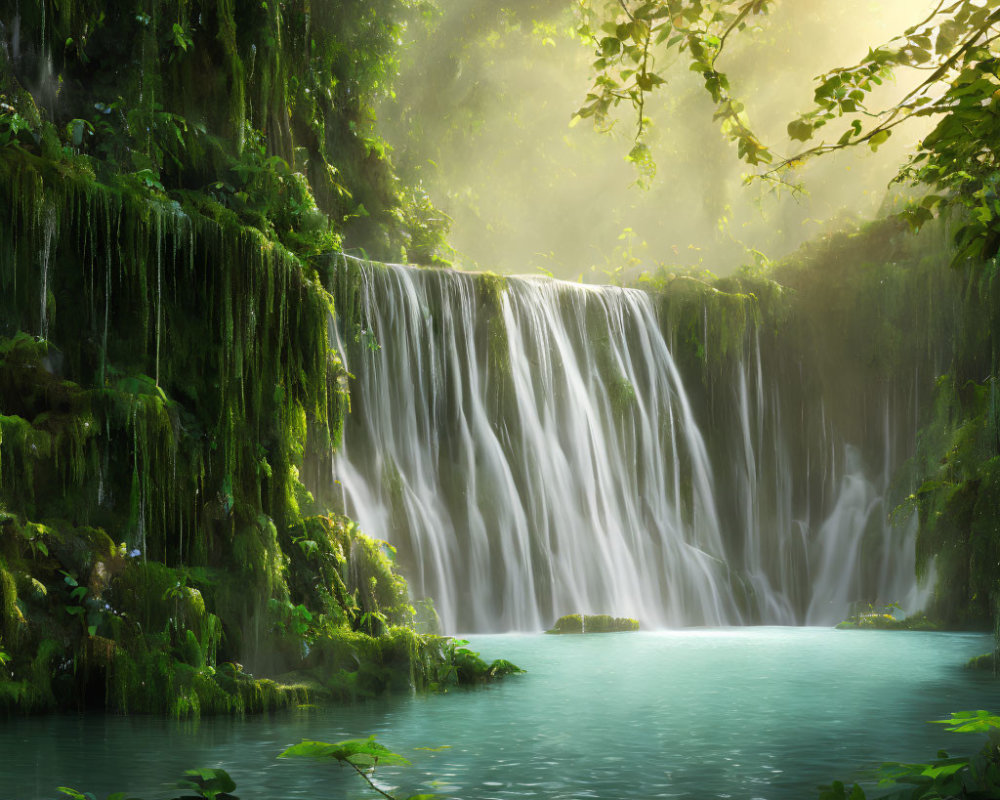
[0,153,458,715]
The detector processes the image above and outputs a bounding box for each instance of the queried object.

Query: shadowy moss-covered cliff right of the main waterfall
[632,214,976,626]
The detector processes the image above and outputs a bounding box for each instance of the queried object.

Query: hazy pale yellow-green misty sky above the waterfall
[380,0,930,281]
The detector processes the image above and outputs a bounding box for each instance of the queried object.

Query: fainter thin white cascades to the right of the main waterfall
[717,336,932,625]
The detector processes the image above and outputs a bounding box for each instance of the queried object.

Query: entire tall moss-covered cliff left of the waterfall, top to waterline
[0,0,512,715]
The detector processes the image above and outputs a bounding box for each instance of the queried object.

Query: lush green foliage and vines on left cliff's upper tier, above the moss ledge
[0,0,443,260]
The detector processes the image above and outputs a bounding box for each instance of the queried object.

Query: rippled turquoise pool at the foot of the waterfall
[0,628,1000,800]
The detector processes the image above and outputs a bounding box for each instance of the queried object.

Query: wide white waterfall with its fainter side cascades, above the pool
[334,259,917,631]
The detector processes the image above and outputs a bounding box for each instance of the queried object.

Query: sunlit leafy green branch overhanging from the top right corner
[577,0,1000,265]
